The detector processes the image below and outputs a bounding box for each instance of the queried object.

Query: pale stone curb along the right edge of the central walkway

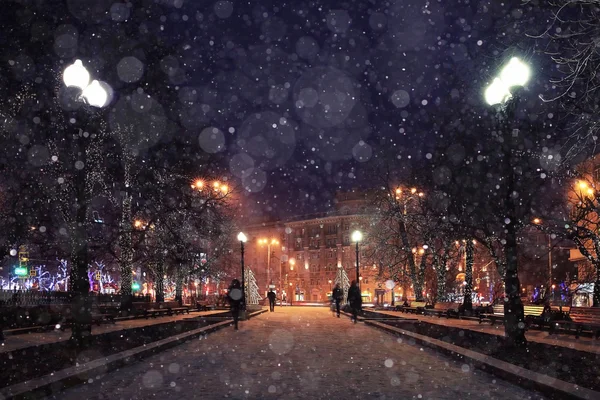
[365,321,600,400]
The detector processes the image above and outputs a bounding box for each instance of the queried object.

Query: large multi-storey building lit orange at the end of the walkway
[240,192,378,302]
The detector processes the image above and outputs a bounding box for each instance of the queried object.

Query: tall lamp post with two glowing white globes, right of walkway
[484,57,531,346]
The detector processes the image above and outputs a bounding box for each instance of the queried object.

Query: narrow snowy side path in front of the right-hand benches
[377,310,600,354]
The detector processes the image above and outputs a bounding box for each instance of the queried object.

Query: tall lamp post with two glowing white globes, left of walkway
[63,60,113,345]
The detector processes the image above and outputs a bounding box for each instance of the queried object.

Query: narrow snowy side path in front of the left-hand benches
[0,310,224,353]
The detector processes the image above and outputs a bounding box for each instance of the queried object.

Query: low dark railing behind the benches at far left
[0,290,151,307]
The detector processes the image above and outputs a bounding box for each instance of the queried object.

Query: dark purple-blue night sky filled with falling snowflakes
[0,0,549,217]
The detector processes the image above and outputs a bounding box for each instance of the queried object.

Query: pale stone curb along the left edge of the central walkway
[0,310,266,400]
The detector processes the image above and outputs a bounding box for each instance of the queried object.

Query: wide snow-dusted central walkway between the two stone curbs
[53,307,542,400]
